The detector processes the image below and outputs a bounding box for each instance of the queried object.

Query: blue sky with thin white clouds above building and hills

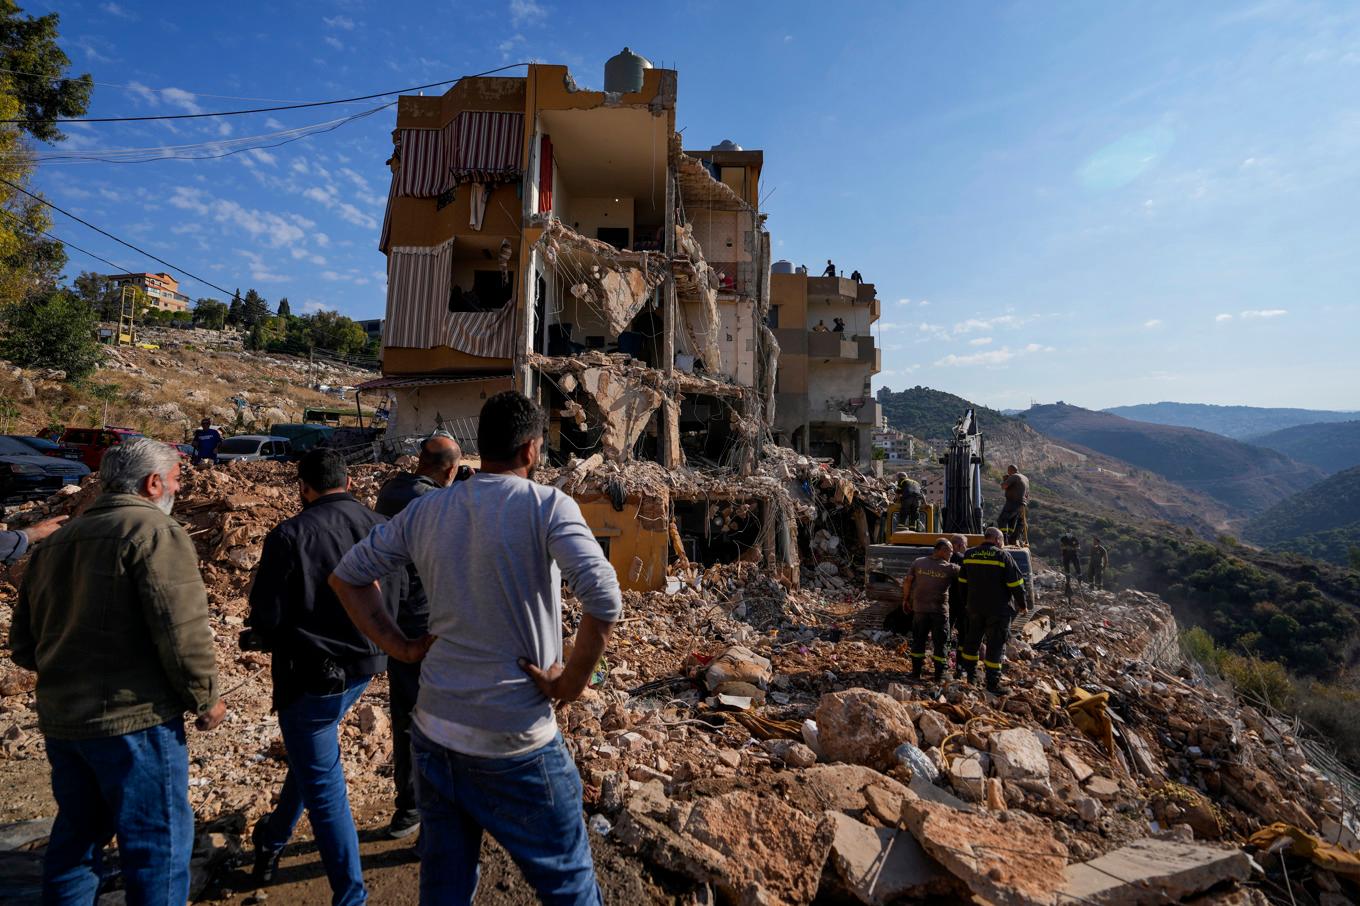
[27,0,1360,409]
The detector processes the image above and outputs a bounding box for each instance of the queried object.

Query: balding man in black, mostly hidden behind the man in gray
[373,434,462,839]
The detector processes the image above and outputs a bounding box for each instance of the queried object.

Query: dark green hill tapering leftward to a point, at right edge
[1242,465,1360,565]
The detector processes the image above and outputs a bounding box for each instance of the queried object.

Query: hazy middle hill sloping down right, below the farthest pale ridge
[1024,403,1323,514]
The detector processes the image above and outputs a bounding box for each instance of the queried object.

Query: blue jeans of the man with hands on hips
[411,726,601,906]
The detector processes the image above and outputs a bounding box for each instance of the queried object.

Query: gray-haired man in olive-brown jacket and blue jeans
[10,438,226,906]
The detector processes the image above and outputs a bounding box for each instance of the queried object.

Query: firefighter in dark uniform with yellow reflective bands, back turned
[959,526,1027,695]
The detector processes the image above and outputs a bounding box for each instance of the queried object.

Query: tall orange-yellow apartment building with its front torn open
[359,49,797,589]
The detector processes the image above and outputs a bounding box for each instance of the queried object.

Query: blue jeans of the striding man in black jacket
[254,676,369,906]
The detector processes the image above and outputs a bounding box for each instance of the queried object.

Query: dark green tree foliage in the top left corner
[0,0,94,141]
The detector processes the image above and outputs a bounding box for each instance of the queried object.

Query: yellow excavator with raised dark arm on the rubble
[865,409,1035,608]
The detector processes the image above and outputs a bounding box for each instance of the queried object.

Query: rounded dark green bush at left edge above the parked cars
[0,290,103,380]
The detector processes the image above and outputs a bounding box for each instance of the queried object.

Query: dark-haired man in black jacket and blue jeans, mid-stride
[242,450,405,906]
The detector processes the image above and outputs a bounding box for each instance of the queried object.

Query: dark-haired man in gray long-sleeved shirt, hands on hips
[330,390,623,906]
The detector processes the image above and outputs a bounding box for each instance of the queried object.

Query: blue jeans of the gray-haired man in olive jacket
[42,718,193,906]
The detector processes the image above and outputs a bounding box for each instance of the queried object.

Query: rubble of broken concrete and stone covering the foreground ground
[0,464,1360,906]
